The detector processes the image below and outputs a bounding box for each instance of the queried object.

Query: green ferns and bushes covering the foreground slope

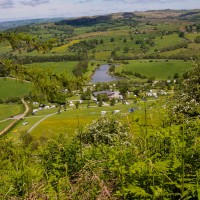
[0,99,200,200]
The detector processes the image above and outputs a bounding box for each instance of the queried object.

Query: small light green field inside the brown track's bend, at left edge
[0,104,23,120]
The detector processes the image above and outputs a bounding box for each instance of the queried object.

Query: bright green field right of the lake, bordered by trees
[116,60,192,79]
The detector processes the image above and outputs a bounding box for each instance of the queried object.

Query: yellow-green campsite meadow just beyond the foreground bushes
[9,101,163,139]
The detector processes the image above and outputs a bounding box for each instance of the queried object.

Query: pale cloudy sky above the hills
[0,0,200,22]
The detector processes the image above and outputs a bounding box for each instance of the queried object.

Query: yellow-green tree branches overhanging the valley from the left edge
[0,33,82,103]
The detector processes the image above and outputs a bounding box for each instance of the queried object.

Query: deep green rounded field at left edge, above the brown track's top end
[0,78,31,99]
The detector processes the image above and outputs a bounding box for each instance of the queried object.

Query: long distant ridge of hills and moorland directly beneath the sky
[0,9,200,31]
